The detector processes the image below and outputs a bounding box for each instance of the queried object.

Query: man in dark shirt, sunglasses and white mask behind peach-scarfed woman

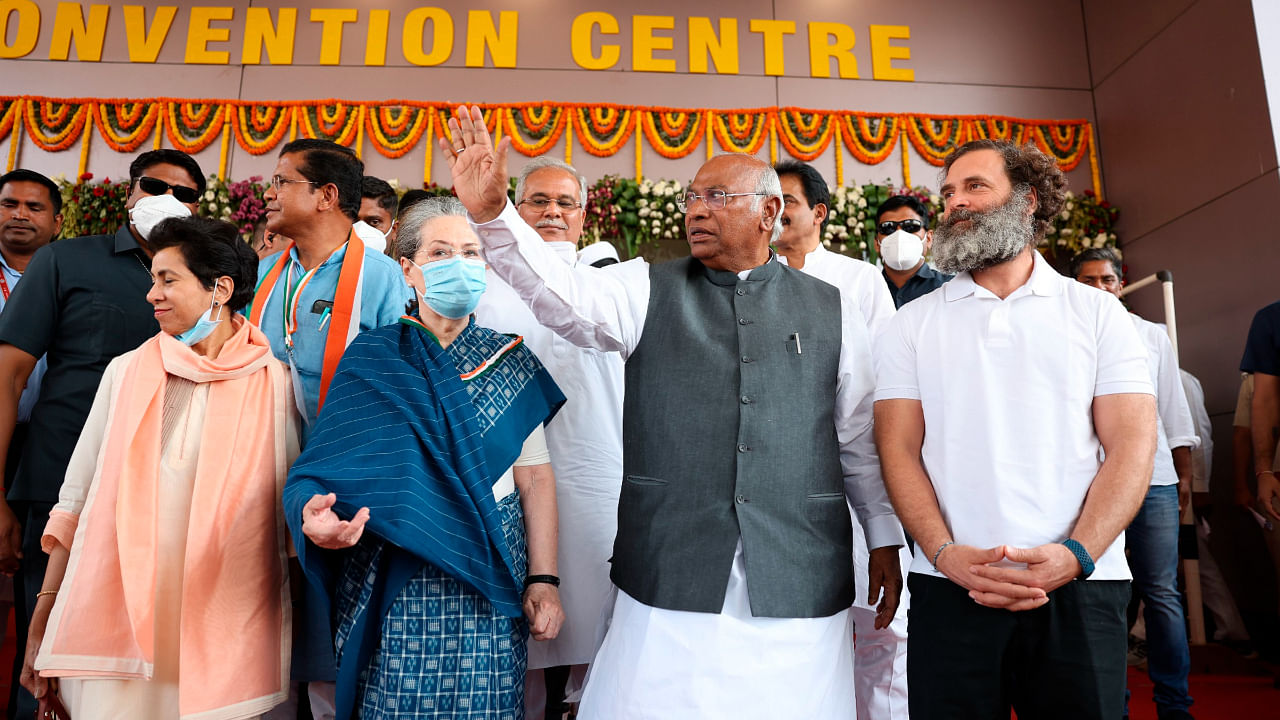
[0,150,205,717]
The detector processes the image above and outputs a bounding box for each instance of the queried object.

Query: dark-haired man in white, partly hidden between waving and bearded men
[773,160,911,720]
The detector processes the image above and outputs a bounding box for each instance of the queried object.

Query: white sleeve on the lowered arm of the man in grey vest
[836,288,906,550]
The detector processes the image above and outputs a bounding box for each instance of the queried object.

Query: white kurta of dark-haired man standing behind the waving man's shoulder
[778,245,911,720]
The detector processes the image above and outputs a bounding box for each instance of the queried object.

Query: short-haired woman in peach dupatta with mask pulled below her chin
[23,218,297,720]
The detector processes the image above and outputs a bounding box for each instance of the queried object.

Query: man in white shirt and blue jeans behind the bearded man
[1069,247,1201,720]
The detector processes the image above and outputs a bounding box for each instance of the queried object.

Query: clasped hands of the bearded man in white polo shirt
[937,543,1080,611]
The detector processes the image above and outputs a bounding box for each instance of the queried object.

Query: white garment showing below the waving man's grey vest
[579,543,856,720]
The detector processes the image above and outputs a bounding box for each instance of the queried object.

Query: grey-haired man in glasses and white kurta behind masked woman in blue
[475,156,622,720]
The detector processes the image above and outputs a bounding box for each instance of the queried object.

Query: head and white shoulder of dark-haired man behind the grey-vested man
[773,160,895,338]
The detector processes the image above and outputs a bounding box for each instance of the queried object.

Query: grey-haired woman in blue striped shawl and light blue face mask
[284,197,564,720]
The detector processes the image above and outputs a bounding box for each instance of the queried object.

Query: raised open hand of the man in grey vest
[438,105,511,223]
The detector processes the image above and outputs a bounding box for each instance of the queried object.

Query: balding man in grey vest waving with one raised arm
[440,108,904,720]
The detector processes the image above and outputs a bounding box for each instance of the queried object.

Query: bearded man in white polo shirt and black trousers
[876,140,1156,720]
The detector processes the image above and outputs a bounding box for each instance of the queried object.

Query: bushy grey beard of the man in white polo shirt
[933,191,1036,274]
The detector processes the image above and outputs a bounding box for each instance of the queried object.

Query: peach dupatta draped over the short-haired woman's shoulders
[36,319,293,719]
